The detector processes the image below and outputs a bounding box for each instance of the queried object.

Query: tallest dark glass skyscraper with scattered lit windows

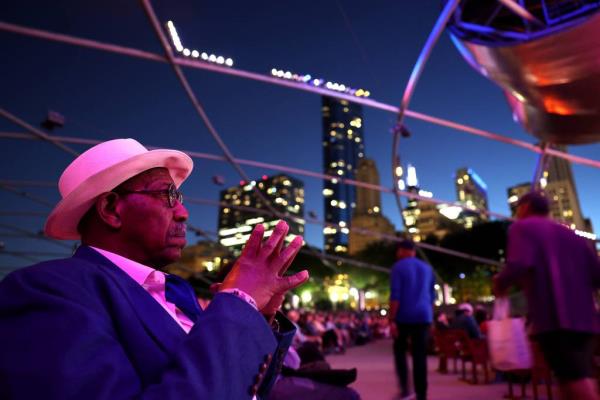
[322,96,365,254]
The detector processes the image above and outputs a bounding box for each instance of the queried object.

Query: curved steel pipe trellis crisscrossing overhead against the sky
[0,0,600,282]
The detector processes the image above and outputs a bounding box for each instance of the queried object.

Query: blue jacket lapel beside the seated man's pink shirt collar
[73,246,186,353]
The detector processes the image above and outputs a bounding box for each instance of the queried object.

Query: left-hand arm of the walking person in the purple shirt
[493,222,537,296]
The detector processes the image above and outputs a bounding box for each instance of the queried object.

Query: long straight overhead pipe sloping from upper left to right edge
[0,22,600,168]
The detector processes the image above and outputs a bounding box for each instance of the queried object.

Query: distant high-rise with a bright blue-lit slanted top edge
[455,168,489,229]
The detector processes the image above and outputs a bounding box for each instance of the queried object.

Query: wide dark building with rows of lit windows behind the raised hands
[218,174,304,255]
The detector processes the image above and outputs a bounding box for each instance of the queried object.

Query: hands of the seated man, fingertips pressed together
[218,221,308,319]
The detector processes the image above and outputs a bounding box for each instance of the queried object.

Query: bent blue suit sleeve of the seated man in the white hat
[0,270,287,400]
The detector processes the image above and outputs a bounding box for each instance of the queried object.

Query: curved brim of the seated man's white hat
[44,149,194,240]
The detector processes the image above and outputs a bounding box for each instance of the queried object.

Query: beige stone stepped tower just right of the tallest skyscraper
[350,158,395,255]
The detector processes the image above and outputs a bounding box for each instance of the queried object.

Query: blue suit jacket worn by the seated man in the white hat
[0,246,294,400]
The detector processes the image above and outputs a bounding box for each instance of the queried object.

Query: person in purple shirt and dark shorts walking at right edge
[494,192,600,400]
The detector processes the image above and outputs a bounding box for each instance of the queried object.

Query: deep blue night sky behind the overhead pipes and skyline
[0,0,600,276]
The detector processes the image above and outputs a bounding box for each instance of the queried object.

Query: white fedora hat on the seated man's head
[44,139,194,240]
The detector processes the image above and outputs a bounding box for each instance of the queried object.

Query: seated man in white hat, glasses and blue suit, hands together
[0,139,308,400]
